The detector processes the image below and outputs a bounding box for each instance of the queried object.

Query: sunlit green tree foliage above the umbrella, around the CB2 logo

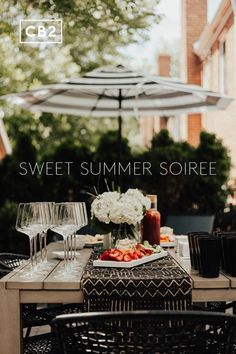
[0,0,160,94]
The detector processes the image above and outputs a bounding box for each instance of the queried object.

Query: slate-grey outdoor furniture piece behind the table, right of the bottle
[166,215,215,235]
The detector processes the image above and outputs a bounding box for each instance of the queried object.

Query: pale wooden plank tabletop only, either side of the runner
[0,242,236,303]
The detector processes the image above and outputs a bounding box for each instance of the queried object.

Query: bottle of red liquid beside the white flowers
[142,194,161,245]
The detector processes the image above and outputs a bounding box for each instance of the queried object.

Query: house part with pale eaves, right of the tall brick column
[194,0,236,179]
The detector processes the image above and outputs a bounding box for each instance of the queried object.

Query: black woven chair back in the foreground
[52,311,236,354]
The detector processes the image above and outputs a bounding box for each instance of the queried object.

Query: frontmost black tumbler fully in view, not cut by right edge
[198,237,220,278]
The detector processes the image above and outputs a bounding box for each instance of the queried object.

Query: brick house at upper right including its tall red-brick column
[142,0,236,179]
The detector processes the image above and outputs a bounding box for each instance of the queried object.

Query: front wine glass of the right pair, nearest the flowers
[52,203,77,277]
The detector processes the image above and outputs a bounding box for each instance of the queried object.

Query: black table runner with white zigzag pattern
[82,252,192,311]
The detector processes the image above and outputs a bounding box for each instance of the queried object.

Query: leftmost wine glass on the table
[16,203,44,277]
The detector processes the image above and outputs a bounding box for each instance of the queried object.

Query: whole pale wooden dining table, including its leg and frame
[0,242,236,354]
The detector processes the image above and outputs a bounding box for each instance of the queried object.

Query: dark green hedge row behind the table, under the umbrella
[0,127,231,252]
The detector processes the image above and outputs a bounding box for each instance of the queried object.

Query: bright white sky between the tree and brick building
[125,0,221,72]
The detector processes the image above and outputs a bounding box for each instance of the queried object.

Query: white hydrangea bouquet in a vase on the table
[91,189,150,239]
